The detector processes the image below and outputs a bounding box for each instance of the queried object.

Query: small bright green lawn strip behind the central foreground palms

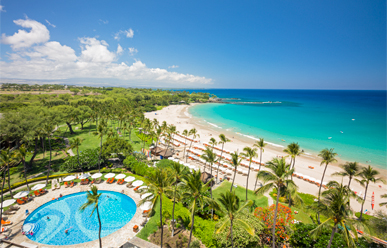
[212,181,269,208]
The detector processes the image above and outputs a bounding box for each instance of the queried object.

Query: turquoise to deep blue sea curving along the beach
[183,89,387,169]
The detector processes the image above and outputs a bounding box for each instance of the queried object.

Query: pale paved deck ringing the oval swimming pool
[0,182,145,248]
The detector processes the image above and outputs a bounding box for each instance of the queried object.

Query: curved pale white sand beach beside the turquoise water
[145,104,387,214]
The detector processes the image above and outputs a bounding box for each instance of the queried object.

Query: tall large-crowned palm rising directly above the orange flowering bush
[255,158,297,248]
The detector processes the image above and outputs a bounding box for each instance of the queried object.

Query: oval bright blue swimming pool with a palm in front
[23,190,137,245]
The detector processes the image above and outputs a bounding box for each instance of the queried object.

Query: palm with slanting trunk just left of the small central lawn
[181,170,219,248]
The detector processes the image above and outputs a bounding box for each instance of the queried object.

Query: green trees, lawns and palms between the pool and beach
[0,84,386,247]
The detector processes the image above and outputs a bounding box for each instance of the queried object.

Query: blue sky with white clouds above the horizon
[0,0,386,90]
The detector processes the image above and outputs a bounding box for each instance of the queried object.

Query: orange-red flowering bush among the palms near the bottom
[254,203,294,243]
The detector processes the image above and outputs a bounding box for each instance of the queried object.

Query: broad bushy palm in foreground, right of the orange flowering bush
[311,182,364,248]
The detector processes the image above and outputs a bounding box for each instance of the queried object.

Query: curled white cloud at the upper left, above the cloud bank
[1,18,50,49]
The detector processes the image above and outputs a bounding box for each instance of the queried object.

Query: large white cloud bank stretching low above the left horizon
[0,20,212,87]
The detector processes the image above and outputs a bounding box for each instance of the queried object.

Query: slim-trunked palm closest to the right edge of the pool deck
[138,168,174,248]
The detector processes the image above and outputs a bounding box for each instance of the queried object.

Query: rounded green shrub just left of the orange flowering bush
[213,211,263,247]
